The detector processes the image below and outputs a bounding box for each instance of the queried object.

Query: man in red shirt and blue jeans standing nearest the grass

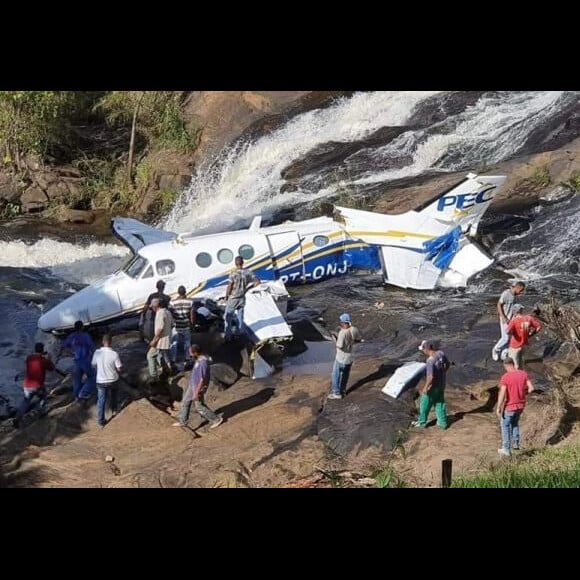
[496,357,534,456]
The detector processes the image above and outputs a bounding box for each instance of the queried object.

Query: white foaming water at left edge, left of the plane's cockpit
[0,238,130,284]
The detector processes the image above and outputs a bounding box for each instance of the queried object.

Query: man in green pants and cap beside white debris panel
[412,340,450,429]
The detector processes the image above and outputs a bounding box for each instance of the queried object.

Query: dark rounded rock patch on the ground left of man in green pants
[317,387,413,457]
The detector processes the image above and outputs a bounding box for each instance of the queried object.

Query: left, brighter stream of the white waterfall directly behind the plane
[163,91,440,233]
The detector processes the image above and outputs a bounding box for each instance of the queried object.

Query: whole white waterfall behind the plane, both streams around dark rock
[162,91,563,232]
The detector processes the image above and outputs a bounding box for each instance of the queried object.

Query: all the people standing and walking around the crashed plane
[14,251,542,455]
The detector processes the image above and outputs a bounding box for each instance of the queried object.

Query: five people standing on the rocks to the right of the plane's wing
[327,282,542,456]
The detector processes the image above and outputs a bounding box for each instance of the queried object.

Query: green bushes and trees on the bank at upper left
[0,91,200,217]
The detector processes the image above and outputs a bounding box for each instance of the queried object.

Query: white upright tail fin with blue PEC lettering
[415,173,506,236]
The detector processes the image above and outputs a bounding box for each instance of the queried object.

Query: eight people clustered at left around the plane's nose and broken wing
[14,256,260,428]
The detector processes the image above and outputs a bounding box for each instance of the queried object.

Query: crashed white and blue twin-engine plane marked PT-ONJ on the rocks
[38,174,506,342]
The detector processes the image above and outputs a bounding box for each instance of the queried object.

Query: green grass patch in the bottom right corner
[451,447,580,488]
